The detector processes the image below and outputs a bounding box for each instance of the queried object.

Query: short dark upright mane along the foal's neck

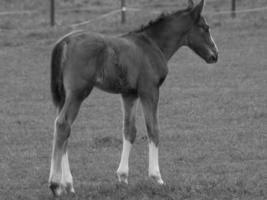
[132,8,189,33]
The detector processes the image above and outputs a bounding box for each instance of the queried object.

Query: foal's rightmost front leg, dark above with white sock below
[140,87,164,185]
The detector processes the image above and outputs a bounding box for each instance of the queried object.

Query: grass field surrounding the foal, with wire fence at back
[0,0,267,200]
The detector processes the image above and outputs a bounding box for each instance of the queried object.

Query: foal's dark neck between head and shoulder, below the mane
[144,12,191,60]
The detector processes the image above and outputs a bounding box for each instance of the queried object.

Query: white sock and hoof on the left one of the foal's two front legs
[117,137,132,184]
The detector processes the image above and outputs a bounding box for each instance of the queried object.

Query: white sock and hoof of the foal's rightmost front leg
[148,142,164,184]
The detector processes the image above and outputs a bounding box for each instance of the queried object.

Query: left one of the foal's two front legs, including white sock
[117,95,137,184]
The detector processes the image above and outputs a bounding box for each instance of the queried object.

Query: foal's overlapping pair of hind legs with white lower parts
[49,90,90,196]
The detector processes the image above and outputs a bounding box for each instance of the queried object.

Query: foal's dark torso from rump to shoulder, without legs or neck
[58,32,167,93]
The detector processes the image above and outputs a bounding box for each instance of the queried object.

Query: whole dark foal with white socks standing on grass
[49,0,218,196]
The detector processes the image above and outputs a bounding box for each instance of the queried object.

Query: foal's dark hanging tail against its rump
[51,40,65,109]
